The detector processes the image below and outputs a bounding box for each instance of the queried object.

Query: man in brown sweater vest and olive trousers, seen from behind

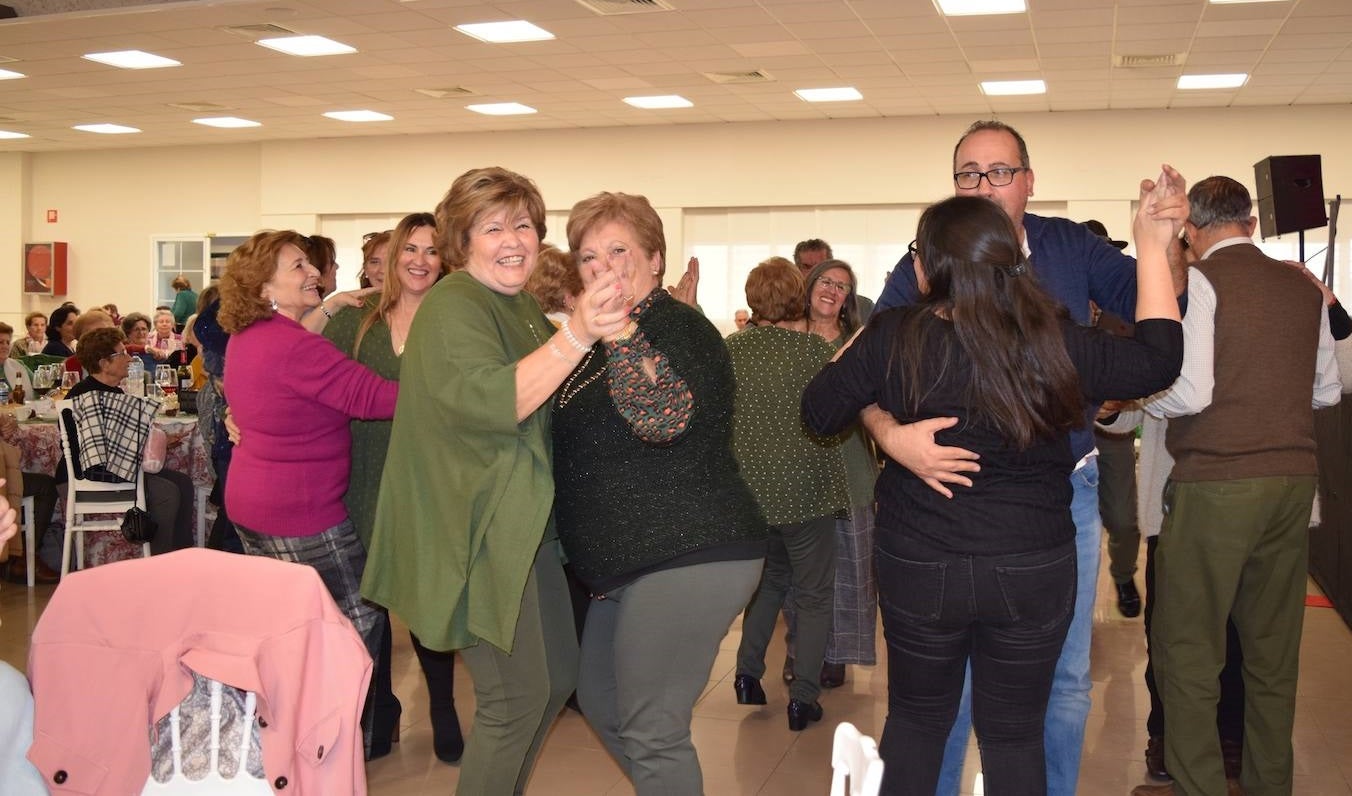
[1133,177,1341,796]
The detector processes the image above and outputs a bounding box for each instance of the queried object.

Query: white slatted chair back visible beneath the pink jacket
[142,672,272,796]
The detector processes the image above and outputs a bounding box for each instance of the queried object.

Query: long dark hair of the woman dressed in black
[894,196,1084,449]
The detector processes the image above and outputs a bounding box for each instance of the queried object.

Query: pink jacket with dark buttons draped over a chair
[28,549,372,795]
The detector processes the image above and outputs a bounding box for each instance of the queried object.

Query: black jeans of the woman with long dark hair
[876,539,1076,796]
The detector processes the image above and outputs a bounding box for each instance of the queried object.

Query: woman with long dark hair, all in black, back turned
[803,168,1187,795]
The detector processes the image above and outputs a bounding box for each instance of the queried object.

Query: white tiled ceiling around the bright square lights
[0,0,1352,151]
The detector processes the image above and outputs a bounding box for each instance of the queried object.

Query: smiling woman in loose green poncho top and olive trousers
[362,168,634,796]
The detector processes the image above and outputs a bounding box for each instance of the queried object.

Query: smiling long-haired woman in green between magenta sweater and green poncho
[324,212,465,762]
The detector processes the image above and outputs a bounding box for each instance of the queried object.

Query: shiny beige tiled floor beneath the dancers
[0,540,1352,796]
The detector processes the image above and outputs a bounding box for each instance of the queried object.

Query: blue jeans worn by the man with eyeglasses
[936,459,1102,796]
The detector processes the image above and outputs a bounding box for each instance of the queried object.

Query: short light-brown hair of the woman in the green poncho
[435,166,545,270]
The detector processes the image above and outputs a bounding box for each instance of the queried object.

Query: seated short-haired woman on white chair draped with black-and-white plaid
[57,328,193,554]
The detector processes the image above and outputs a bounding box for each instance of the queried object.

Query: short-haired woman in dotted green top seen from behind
[727,262,848,731]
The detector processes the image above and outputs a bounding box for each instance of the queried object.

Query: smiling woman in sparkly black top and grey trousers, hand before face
[554,193,765,796]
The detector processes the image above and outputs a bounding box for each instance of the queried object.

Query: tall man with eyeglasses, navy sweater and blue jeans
[861,120,1187,796]
